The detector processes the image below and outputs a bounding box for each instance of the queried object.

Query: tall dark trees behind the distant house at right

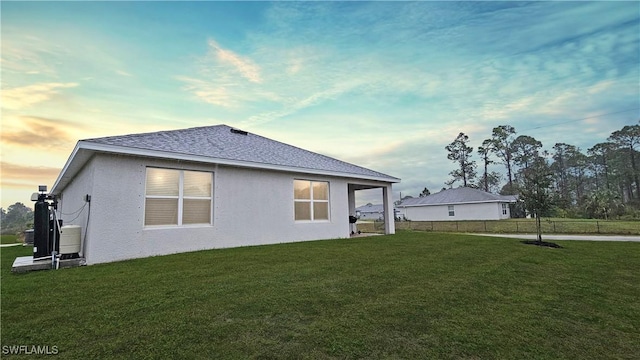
[442,122,640,219]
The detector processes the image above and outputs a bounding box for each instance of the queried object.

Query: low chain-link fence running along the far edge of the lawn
[357,220,640,235]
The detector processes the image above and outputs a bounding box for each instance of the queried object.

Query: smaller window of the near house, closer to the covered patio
[293,180,329,221]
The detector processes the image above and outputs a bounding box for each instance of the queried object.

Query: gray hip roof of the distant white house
[397,187,517,207]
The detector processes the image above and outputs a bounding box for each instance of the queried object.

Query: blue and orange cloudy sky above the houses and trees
[0,1,640,209]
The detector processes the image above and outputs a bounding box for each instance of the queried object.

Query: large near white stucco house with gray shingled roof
[51,125,400,264]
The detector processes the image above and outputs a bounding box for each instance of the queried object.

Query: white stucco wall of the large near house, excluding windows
[63,154,349,264]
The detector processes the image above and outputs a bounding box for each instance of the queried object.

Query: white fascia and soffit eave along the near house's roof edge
[51,140,400,194]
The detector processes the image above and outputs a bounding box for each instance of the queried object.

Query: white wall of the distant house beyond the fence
[403,202,509,221]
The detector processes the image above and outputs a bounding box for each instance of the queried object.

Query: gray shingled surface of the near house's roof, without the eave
[81,125,399,182]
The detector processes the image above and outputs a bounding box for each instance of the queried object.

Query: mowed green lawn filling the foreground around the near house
[1,232,640,359]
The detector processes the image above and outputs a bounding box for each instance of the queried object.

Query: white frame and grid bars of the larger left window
[142,166,214,228]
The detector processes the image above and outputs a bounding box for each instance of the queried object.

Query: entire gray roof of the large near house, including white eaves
[51,125,400,193]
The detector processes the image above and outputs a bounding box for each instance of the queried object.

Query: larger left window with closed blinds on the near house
[144,168,213,226]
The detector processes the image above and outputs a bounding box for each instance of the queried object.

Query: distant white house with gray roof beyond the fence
[396,187,517,221]
